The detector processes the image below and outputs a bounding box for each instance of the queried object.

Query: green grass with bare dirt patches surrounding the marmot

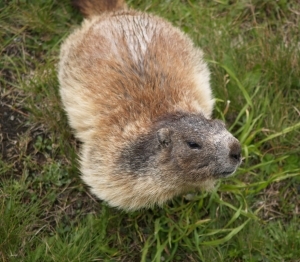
[0,0,300,262]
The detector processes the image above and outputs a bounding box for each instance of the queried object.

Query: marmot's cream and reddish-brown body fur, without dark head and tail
[58,1,239,210]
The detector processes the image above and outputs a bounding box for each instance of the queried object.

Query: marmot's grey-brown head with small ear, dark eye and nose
[157,115,241,184]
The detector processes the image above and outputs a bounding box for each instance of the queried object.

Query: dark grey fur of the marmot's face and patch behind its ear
[120,114,241,185]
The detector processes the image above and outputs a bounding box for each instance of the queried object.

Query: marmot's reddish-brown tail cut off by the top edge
[72,0,127,17]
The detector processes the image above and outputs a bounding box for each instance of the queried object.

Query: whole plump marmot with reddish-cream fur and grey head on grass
[58,0,241,210]
